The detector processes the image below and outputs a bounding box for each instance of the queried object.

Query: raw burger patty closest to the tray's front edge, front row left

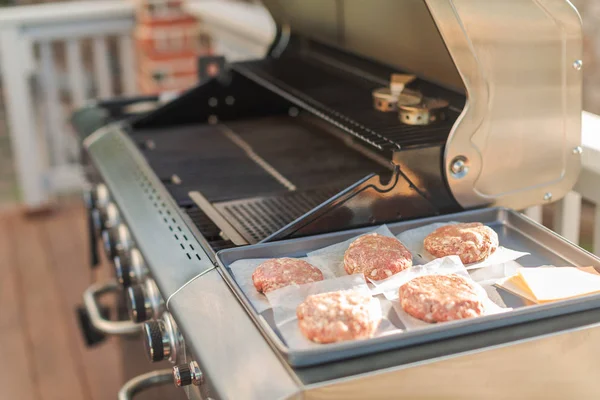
[296,290,381,343]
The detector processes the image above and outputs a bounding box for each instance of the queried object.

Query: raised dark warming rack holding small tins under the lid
[235,56,459,151]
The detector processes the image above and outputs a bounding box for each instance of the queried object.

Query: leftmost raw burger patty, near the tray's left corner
[252,258,323,293]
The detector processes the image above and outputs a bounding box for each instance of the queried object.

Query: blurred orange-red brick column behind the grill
[135,0,211,94]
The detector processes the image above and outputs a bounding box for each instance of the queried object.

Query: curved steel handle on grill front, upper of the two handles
[83,281,141,335]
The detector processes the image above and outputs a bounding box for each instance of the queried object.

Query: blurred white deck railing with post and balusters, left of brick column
[0,0,136,208]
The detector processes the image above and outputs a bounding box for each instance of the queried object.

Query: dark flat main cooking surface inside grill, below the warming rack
[133,116,385,206]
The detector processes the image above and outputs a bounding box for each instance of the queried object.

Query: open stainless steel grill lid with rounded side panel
[264,0,582,209]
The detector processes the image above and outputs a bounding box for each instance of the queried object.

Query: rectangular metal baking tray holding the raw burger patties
[217,208,600,367]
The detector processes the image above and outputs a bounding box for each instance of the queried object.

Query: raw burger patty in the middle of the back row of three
[344,233,412,281]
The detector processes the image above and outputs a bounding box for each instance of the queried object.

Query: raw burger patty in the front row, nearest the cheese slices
[400,274,484,322]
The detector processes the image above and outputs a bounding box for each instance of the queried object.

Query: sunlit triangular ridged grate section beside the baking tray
[215,187,342,243]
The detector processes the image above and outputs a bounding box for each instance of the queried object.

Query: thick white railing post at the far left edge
[0,26,49,208]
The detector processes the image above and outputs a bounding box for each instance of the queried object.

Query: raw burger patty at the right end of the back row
[423,222,498,264]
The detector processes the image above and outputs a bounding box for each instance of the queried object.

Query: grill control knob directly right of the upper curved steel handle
[127,279,165,322]
